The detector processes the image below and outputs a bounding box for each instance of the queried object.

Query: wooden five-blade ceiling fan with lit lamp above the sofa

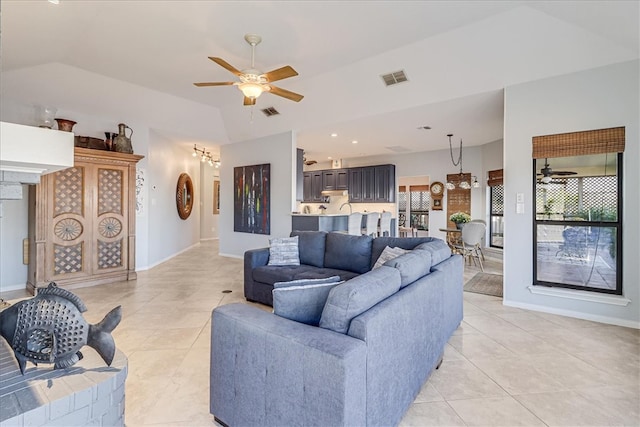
[194,34,304,105]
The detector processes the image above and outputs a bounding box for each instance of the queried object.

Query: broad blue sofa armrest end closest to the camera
[210,304,367,426]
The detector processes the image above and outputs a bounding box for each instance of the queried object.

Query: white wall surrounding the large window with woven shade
[504,61,640,328]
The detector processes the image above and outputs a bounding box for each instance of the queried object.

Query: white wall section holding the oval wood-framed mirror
[147,131,201,267]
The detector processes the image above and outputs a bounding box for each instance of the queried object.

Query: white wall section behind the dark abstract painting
[219,132,296,258]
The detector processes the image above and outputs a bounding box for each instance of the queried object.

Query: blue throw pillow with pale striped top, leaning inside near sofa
[272,276,342,326]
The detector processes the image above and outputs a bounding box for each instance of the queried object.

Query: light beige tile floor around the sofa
[2,241,640,427]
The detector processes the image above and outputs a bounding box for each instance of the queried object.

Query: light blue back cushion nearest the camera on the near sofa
[320,266,400,334]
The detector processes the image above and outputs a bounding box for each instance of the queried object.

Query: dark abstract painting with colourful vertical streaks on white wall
[233,163,271,234]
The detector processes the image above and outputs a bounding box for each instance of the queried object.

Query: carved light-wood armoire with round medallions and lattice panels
[27,147,143,293]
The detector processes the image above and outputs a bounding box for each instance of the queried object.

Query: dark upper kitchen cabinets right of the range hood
[349,165,396,203]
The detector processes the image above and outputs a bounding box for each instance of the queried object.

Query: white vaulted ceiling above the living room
[0,0,640,160]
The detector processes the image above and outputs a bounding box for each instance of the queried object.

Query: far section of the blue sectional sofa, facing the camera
[244,231,435,305]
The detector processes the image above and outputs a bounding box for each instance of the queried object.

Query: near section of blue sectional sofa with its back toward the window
[210,234,463,427]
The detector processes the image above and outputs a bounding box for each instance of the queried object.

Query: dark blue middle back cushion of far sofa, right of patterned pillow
[324,233,376,274]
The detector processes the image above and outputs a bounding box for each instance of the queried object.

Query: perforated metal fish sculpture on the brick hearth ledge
[0,282,122,374]
